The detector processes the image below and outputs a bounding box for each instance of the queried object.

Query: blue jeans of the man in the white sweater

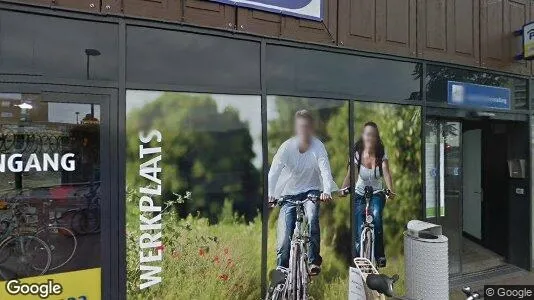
[276,190,322,268]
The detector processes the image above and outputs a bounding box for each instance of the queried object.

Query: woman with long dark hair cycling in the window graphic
[342,122,395,267]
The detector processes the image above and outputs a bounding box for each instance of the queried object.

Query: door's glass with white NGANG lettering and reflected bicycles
[0,93,100,280]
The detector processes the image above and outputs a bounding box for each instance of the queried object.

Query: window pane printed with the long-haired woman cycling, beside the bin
[353,102,422,294]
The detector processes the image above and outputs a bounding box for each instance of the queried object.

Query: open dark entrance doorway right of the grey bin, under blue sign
[425,118,530,274]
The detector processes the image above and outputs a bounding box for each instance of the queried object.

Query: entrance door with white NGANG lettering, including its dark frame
[0,83,116,298]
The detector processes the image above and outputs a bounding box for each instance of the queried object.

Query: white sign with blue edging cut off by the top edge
[211,0,323,21]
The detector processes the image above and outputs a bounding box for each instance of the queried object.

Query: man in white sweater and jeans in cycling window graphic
[269,110,337,275]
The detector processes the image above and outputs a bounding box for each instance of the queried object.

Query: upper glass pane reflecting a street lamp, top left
[0,10,119,81]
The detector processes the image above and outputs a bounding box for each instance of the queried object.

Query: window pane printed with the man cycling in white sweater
[267,96,352,299]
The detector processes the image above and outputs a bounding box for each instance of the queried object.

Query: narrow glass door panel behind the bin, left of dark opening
[425,119,462,274]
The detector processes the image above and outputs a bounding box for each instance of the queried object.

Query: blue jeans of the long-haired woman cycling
[354,193,386,263]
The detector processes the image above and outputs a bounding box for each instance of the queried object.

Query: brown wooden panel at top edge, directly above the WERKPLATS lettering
[122,0,182,21]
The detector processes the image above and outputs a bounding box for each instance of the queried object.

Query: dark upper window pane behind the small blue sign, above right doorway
[425,65,528,109]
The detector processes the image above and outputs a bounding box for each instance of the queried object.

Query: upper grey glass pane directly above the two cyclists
[265,45,421,101]
